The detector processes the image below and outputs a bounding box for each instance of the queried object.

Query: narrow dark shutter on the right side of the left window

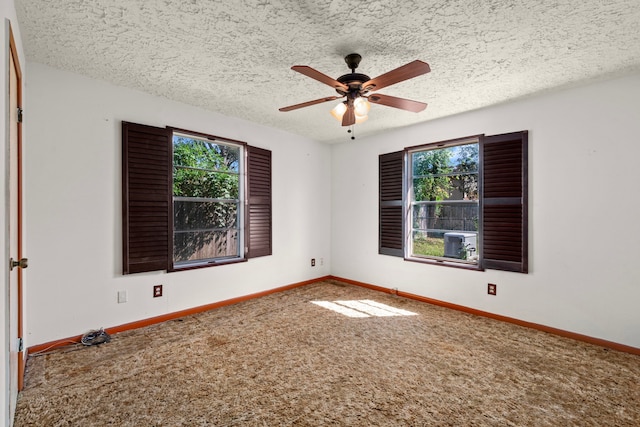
[246,145,272,258]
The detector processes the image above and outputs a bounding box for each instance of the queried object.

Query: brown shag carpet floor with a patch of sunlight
[15,281,640,427]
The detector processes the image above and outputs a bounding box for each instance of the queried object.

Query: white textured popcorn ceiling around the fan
[15,0,640,143]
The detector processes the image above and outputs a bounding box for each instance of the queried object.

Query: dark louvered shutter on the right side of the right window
[480,131,528,273]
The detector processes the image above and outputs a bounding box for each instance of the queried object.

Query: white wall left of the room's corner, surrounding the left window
[25,63,331,346]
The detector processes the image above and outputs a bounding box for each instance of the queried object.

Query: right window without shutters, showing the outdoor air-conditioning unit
[407,138,480,264]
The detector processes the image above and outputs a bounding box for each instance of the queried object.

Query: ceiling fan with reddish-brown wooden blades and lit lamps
[280,53,431,126]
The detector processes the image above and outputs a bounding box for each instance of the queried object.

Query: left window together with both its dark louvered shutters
[122,122,271,274]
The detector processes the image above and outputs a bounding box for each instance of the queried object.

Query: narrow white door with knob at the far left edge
[7,28,26,426]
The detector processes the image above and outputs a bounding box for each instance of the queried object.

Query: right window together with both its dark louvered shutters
[379,131,528,273]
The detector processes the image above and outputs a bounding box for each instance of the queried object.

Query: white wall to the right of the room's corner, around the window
[331,75,640,347]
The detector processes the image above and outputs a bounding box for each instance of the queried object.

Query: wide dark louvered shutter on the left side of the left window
[122,122,173,274]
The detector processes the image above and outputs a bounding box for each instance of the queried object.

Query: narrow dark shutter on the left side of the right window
[378,151,404,257]
